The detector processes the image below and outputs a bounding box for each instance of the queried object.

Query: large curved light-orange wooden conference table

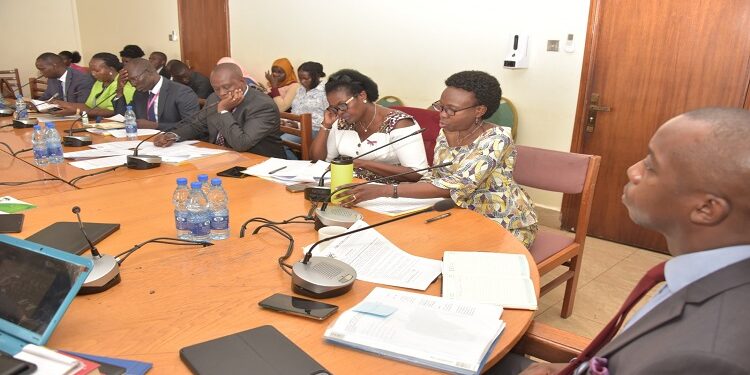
[0,116,539,374]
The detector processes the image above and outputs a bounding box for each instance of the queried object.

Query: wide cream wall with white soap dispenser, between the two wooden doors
[229,0,589,208]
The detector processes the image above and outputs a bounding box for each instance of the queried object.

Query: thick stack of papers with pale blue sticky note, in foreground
[324,288,505,374]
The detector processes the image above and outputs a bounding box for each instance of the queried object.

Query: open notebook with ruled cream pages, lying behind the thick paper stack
[443,251,537,310]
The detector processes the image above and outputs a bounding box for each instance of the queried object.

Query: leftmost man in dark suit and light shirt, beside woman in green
[36,52,94,103]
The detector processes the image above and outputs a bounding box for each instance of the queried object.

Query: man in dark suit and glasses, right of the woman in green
[112,58,199,131]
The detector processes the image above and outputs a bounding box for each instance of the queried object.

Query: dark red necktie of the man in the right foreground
[560,262,666,375]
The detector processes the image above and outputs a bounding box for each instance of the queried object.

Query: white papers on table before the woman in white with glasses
[242,158,330,185]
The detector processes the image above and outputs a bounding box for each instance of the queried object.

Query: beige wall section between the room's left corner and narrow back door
[76,0,180,62]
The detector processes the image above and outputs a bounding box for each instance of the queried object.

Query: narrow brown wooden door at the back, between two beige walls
[177,0,231,76]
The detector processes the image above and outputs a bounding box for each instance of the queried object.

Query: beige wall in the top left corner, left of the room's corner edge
[0,0,81,91]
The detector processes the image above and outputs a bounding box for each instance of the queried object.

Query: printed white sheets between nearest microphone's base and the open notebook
[313,220,442,290]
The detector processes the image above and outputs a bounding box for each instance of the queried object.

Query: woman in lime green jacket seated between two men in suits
[55,52,135,120]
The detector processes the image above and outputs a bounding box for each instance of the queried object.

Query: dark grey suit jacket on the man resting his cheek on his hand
[173,88,286,159]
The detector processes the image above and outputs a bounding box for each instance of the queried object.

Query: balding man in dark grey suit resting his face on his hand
[154,64,285,158]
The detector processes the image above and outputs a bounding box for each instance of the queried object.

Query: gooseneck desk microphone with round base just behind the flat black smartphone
[292,199,456,298]
